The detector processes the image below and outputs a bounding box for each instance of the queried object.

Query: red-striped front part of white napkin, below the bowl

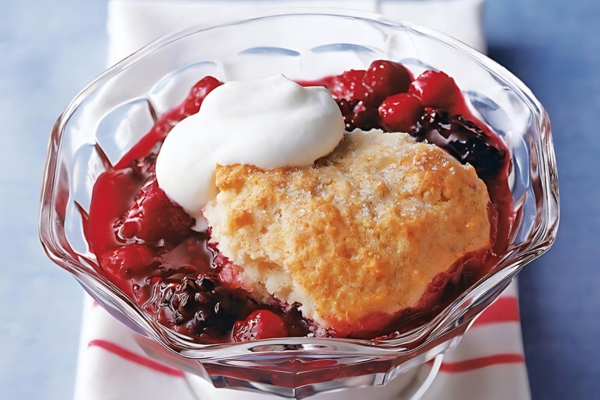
[75,284,530,400]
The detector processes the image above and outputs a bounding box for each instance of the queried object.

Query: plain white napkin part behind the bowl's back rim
[108,0,486,61]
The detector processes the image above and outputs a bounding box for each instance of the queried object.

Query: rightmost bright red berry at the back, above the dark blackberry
[409,70,462,109]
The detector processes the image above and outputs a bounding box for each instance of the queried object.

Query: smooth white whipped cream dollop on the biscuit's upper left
[156,75,344,231]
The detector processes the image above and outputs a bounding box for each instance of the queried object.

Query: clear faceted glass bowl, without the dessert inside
[40,11,559,397]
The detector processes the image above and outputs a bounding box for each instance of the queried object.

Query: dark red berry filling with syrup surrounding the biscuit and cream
[84,61,514,343]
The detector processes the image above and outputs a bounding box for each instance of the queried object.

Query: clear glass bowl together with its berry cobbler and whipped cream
[42,10,557,394]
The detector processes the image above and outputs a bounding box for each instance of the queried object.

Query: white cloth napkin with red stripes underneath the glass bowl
[75,0,530,400]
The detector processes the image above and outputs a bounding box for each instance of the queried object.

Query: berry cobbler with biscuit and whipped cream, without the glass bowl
[84,60,513,343]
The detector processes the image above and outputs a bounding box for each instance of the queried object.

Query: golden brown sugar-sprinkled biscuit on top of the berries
[204,130,491,336]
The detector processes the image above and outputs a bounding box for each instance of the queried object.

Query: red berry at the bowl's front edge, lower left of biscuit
[233,310,288,342]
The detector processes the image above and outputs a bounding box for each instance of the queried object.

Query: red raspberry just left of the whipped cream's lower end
[119,181,194,244]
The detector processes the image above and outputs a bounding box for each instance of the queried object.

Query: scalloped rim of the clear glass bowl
[40,9,559,359]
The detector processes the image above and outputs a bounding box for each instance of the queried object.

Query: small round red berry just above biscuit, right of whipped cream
[379,93,424,132]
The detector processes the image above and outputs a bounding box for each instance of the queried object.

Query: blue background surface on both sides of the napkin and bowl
[0,0,600,400]
